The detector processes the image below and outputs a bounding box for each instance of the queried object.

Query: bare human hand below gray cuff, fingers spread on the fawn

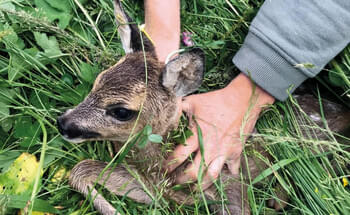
[166,74,275,189]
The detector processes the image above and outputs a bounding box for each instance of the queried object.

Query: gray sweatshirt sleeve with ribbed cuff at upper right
[233,0,350,100]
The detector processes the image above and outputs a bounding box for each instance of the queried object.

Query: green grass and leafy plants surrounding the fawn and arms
[0,0,350,214]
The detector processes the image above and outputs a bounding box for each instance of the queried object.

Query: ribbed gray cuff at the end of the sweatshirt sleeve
[232,32,308,101]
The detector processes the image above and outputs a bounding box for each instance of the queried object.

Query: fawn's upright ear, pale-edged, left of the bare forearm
[113,0,154,54]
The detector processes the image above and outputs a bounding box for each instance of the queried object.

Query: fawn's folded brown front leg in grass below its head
[69,160,152,215]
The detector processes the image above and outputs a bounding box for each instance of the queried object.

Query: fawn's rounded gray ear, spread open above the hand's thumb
[162,48,205,97]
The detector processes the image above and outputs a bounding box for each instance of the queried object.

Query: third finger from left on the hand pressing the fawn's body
[202,156,226,190]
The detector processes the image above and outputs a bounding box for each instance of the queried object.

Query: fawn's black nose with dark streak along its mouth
[57,116,100,139]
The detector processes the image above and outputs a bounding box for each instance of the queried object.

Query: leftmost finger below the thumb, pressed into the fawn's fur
[165,130,198,173]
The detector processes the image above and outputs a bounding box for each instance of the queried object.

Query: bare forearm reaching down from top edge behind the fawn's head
[145,0,180,61]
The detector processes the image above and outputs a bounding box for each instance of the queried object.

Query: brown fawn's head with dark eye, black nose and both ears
[57,0,204,142]
